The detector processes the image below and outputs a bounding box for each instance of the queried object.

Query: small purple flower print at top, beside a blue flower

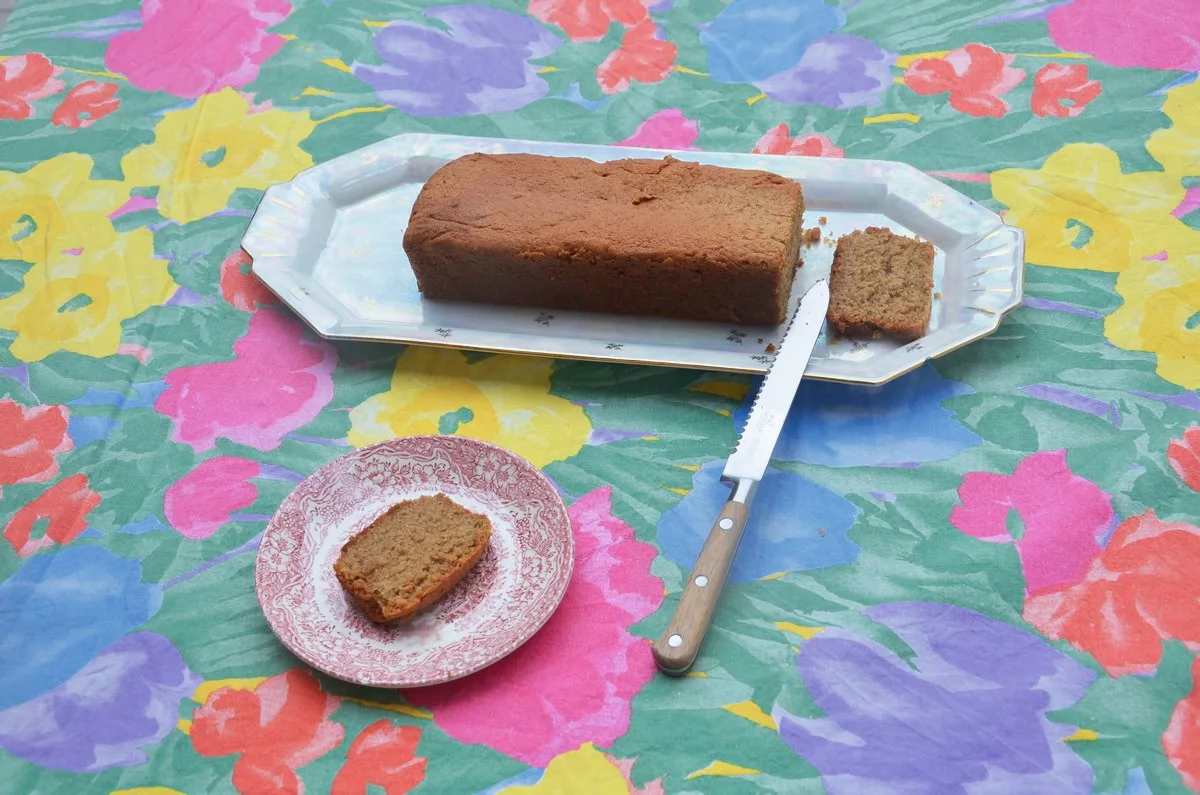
[755,34,896,108]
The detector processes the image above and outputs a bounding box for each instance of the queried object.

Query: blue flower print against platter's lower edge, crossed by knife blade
[733,365,980,467]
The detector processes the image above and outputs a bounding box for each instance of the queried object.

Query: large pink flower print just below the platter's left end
[155,310,337,453]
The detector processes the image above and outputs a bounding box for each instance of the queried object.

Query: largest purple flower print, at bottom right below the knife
[775,602,1096,795]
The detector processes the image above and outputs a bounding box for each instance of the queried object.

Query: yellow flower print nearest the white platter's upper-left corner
[121,89,316,223]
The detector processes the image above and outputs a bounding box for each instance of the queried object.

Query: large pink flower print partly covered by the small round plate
[406,488,662,767]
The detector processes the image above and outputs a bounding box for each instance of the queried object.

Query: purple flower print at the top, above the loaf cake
[353,6,560,116]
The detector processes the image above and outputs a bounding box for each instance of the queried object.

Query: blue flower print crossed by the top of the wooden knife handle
[659,461,859,582]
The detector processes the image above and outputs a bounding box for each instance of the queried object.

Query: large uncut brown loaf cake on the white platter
[404,155,804,324]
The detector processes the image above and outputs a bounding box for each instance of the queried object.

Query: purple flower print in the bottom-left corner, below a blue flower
[0,632,199,773]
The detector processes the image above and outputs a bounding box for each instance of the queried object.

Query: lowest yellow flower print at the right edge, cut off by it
[1104,246,1200,389]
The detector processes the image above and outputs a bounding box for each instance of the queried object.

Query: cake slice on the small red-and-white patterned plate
[334,494,492,623]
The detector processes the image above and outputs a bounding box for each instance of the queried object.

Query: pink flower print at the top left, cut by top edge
[104,0,292,98]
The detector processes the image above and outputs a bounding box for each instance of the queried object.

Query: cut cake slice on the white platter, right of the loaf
[828,227,934,342]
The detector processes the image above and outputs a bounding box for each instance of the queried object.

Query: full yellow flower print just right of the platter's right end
[991,144,1190,271]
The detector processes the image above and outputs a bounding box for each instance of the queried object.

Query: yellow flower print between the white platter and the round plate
[347,346,592,467]
